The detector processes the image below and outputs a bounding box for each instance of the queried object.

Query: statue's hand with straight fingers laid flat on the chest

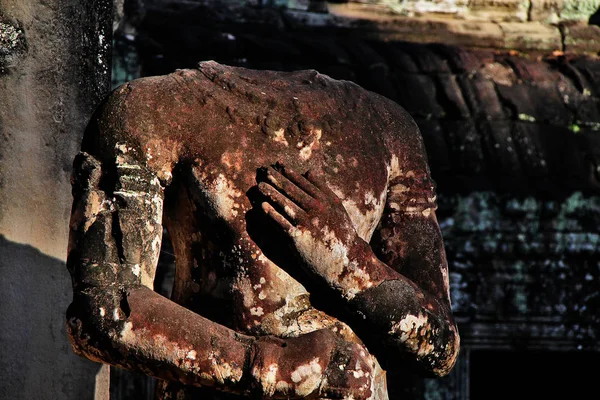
[258,164,370,297]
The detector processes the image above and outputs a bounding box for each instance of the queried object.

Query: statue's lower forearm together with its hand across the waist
[67,286,386,400]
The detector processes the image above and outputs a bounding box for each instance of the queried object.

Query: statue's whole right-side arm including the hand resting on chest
[259,136,460,376]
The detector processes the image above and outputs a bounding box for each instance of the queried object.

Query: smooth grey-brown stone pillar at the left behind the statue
[0,0,112,400]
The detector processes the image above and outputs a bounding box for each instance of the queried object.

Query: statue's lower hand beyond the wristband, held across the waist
[251,329,387,400]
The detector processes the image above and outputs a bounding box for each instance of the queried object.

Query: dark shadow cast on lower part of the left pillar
[0,235,101,400]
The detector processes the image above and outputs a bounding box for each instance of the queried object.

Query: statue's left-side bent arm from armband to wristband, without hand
[67,153,254,390]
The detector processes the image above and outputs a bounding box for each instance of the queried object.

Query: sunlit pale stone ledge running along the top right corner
[329,1,600,54]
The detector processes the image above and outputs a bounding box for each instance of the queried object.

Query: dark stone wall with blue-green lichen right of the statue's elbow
[440,192,600,350]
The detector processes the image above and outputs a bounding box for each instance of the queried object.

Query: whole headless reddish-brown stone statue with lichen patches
[67,62,459,400]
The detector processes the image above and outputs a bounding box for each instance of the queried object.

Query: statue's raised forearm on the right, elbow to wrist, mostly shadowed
[318,239,460,376]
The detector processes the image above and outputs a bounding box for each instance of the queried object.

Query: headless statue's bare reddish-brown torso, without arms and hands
[109,63,397,336]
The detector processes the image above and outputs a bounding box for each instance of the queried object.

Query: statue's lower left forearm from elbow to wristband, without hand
[67,286,254,393]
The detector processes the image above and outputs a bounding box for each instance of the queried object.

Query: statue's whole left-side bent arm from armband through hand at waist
[67,145,374,399]
